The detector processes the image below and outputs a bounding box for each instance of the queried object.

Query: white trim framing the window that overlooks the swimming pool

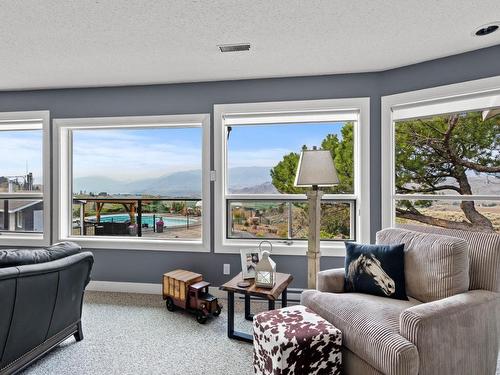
[53,114,210,252]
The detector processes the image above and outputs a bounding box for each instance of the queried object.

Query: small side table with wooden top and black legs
[220,272,293,342]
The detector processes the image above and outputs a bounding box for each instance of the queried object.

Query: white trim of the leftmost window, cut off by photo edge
[0,111,52,246]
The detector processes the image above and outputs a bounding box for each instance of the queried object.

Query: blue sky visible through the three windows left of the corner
[0,123,343,183]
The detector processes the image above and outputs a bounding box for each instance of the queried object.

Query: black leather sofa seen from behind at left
[0,242,94,375]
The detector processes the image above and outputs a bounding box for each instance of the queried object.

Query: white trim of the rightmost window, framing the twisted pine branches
[381,76,500,228]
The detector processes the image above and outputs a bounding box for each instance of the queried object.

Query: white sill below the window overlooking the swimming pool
[59,236,210,253]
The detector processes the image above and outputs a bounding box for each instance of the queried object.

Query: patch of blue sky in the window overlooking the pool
[73,128,202,181]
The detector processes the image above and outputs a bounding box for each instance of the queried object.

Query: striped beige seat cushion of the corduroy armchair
[301,290,420,375]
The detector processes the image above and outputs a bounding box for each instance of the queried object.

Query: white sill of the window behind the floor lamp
[215,240,345,257]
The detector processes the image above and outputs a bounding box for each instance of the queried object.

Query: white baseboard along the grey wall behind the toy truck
[87,280,302,301]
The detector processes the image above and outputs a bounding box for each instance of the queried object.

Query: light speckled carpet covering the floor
[18,292,500,375]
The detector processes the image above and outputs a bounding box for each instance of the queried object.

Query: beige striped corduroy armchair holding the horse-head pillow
[301,226,500,375]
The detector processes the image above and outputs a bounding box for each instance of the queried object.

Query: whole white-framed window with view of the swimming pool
[56,115,209,250]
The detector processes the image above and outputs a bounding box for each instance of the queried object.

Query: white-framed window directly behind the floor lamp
[215,99,369,254]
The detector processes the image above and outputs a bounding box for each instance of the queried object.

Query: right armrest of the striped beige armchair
[400,290,500,375]
